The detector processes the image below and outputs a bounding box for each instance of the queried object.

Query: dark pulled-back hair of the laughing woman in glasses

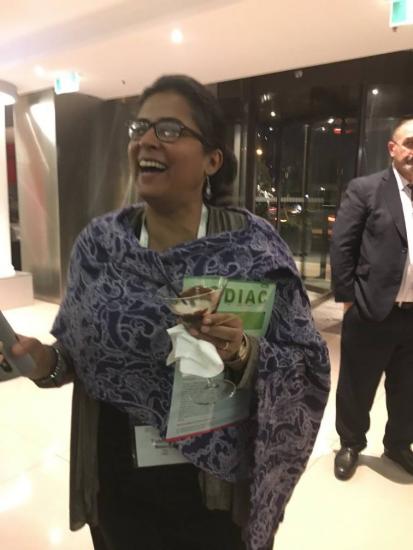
[139,75,237,206]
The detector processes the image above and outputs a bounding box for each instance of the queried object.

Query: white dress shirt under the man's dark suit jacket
[393,166,413,303]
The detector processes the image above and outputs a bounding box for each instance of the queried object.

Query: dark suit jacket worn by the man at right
[331,168,408,321]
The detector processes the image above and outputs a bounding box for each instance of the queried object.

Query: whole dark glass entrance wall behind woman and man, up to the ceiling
[217,51,413,300]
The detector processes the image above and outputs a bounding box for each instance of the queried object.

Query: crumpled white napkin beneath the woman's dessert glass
[166,324,224,378]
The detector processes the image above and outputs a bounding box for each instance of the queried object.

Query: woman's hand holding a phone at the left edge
[0,334,56,380]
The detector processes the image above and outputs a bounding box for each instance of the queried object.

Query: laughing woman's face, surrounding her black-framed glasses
[128,92,222,208]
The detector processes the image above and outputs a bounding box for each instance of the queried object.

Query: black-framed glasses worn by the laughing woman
[128,118,206,145]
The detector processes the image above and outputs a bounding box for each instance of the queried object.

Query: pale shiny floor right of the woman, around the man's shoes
[274,300,413,550]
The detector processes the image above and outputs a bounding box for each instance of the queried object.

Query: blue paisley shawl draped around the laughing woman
[52,208,329,550]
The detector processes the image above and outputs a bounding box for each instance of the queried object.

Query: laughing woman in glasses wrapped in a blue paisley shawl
[0,76,329,550]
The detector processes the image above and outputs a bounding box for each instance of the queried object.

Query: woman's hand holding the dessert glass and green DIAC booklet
[188,313,244,361]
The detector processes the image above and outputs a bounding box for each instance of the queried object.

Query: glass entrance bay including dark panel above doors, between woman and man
[254,84,361,292]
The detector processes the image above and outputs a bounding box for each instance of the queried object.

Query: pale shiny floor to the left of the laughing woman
[0,302,93,550]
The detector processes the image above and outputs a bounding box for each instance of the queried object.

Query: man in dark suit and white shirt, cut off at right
[331,118,413,480]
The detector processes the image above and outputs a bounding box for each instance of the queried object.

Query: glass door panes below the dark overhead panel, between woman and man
[251,116,358,293]
